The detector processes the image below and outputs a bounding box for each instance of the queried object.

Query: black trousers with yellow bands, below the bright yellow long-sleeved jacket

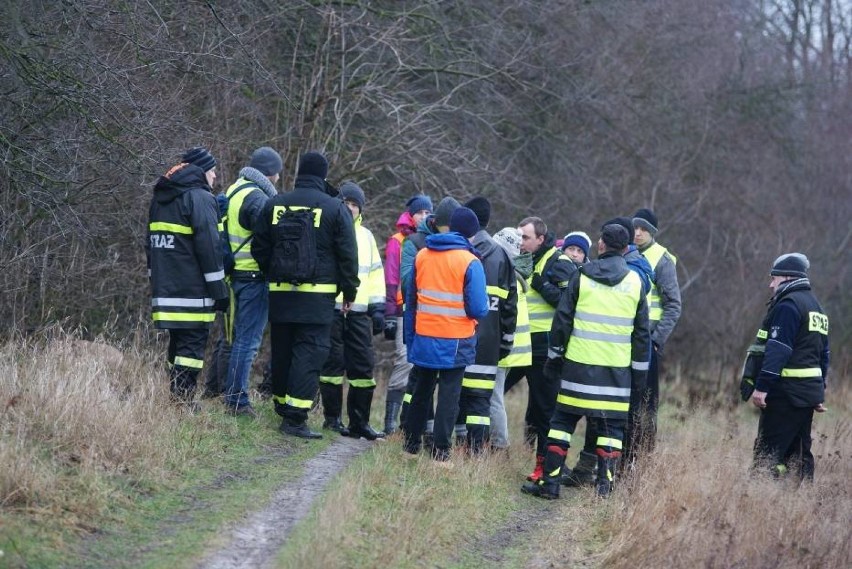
[320,311,376,425]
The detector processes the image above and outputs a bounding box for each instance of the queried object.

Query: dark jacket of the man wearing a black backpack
[251,175,360,324]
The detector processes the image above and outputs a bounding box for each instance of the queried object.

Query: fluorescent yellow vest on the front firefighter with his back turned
[565,271,642,367]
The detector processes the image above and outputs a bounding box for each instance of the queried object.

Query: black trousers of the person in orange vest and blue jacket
[405,365,464,460]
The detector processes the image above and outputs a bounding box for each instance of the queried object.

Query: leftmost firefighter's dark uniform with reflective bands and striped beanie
[146,155,228,401]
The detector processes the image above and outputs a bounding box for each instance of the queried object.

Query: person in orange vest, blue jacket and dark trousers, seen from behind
[405,207,488,467]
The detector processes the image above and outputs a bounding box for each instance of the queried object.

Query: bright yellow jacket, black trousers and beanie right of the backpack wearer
[320,191,385,440]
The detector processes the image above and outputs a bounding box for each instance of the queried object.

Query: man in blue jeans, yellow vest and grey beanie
[223,146,284,417]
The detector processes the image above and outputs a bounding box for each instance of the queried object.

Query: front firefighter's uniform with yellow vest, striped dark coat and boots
[523,240,650,498]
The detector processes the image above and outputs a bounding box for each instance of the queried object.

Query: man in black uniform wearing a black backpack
[251,152,359,439]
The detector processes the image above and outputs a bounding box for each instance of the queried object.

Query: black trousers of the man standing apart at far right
[754,396,814,480]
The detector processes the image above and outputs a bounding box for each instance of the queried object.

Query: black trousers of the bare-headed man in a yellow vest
[504,358,560,456]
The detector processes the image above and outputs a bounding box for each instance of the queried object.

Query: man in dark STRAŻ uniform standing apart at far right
[751,253,829,480]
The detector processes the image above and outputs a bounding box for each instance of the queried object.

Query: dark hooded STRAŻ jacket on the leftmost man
[146,164,228,328]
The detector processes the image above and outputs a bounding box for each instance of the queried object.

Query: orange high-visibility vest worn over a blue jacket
[414,249,476,338]
